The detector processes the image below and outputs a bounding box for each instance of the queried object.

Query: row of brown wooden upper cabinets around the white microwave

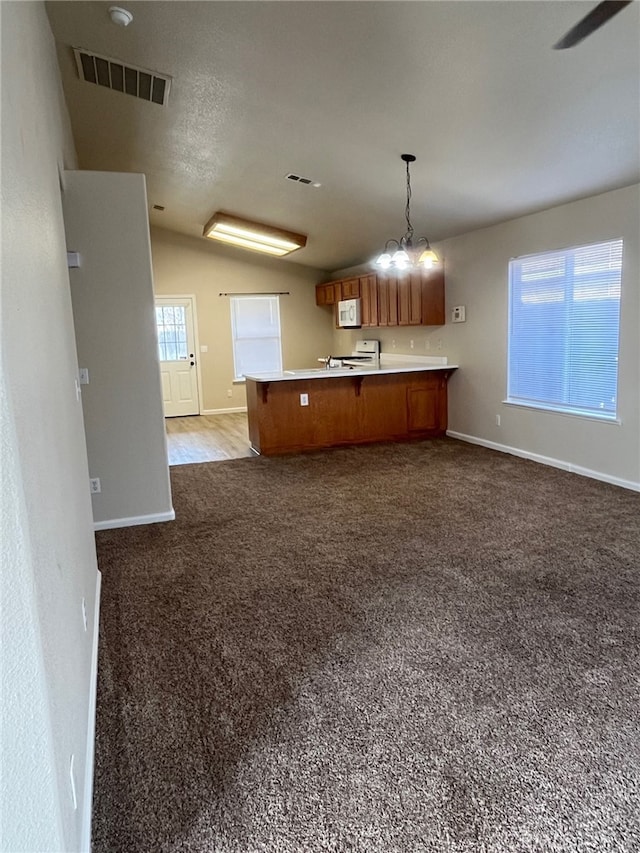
[316,267,445,328]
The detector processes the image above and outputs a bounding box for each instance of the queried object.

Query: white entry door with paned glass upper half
[156,297,200,418]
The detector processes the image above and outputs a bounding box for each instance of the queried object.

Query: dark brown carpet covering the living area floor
[94,440,640,853]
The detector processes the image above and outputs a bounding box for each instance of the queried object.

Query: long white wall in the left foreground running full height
[0,2,98,853]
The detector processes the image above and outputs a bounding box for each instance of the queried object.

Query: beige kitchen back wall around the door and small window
[151,228,333,412]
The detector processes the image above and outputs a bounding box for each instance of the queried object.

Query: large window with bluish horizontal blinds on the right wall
[507,240,622,420]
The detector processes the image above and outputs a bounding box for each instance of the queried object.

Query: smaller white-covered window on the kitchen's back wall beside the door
[231,296,282,379]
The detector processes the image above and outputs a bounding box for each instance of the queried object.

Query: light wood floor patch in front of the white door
[165,412,254,465]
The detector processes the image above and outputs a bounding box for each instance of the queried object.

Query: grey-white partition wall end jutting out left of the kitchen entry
[63,172,173,527]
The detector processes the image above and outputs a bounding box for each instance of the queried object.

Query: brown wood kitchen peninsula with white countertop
[246,356,457,456]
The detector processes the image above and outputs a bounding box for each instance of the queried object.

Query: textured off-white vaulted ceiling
[47,0,640,270]
